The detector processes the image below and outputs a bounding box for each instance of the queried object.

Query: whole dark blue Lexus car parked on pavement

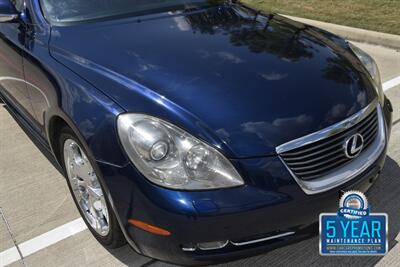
[0,0,392,265]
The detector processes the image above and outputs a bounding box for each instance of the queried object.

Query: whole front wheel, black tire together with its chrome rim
[59,127,126,249]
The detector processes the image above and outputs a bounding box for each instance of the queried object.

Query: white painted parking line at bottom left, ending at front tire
[0,218,87,266]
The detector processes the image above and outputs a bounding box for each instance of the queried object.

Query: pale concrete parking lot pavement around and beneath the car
[0,44,400,267]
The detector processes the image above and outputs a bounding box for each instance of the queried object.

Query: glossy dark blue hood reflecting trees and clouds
[50,5,376,158]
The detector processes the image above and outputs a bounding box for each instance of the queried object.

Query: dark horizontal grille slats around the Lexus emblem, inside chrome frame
[278,104,379,181]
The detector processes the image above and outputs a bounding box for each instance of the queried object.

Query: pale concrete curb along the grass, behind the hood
[282,15,400,50]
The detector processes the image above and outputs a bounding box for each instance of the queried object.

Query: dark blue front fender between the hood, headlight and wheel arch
[44,60,128,166]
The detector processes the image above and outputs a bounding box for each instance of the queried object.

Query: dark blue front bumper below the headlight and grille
[98,97,392,265]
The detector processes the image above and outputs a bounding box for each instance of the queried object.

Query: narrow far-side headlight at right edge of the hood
[349,43,385,105]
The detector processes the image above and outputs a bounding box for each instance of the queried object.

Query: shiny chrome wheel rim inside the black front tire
[64,139,110,236]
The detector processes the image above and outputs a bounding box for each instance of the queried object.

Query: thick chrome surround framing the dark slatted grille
[279,101,386,195]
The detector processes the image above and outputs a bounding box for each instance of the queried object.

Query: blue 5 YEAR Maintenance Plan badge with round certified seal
[319,191,388,256]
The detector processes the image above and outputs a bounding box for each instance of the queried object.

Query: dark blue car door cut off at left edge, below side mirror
[0,0,33,118]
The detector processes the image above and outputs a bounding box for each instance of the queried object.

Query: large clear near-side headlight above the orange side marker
[117,114,244,190]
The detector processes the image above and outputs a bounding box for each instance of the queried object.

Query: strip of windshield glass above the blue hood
[41,0,224,22]
